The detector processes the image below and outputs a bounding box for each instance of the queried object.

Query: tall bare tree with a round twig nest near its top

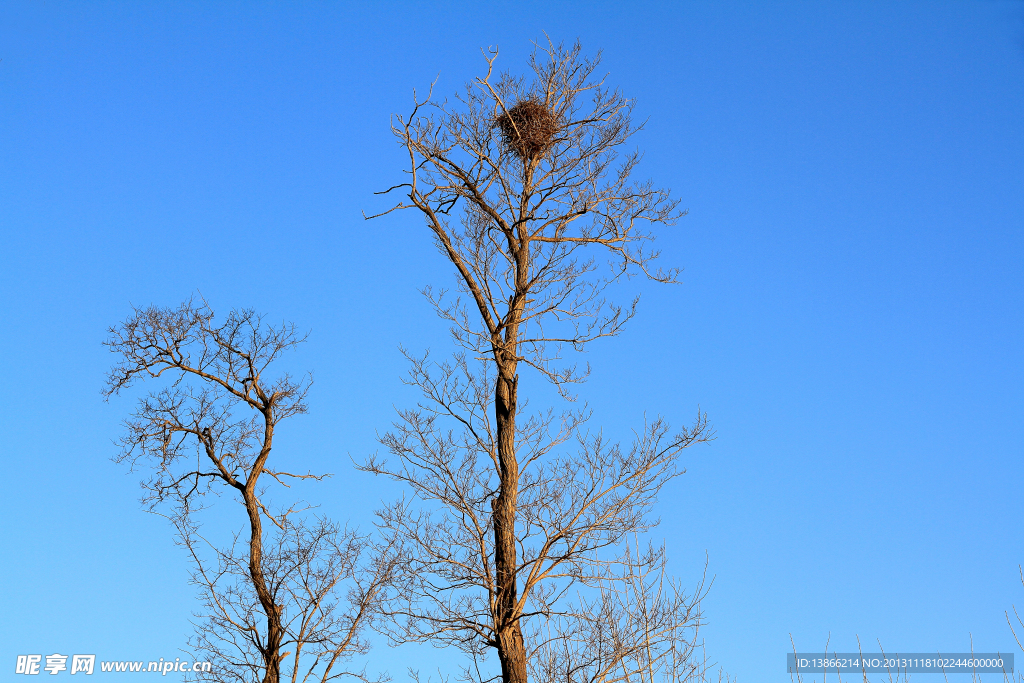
[365,43,711,683]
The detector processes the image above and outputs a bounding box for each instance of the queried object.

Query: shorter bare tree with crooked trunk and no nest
[104,301,390,683]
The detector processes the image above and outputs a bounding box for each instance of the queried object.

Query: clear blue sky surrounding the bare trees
[0,0,1024,682]
